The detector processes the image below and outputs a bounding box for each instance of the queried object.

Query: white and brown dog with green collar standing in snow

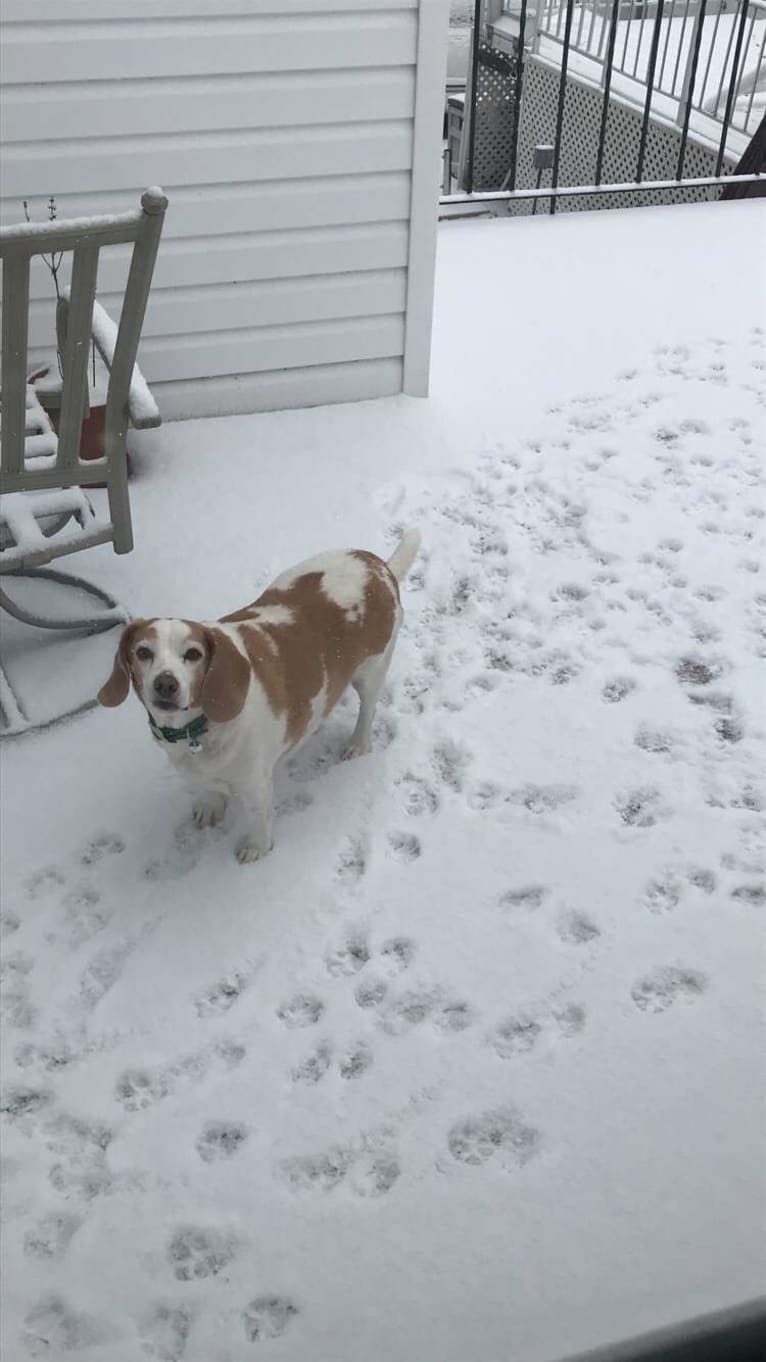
[98,530,420,862]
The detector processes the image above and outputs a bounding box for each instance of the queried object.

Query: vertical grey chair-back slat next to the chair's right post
[57,244,98,469]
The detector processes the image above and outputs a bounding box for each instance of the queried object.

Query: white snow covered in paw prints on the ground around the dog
[3,200,766,1362]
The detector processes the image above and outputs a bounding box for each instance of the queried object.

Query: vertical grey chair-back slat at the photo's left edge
[0,251,29,473]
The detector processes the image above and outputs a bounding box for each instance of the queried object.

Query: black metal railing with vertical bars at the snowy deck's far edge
[443,0,766,214]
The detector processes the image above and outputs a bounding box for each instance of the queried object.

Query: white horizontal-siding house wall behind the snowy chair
[0,0,447,418]
